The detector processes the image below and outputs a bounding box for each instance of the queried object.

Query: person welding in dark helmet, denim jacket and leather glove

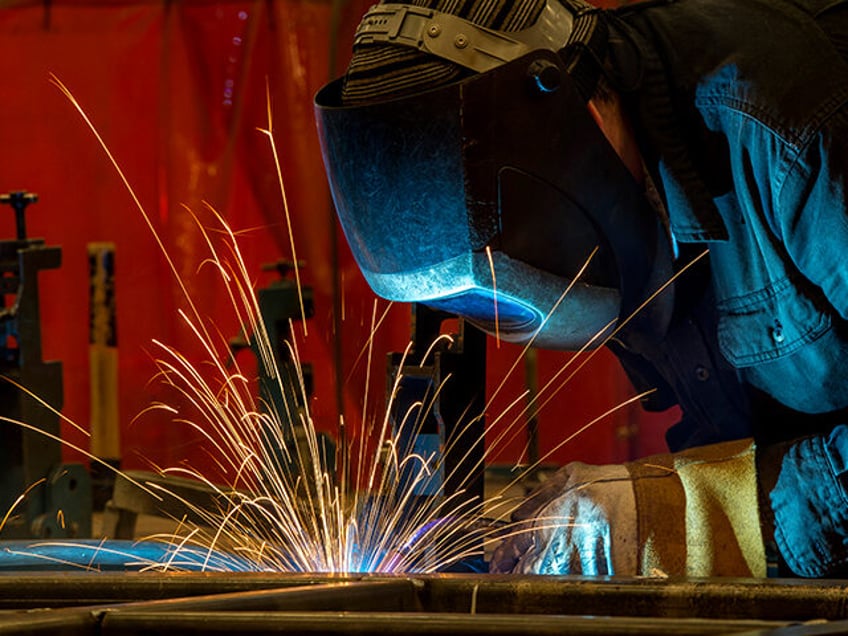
[316,0,848,577]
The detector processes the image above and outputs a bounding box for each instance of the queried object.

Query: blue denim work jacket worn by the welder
[613,0,848,576]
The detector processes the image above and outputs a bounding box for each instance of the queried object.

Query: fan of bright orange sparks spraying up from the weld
[0,77,696,572]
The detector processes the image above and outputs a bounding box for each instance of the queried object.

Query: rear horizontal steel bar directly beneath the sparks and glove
[0,572,848,620]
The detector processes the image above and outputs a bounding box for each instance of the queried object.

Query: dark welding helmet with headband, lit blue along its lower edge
[315,0,659,349]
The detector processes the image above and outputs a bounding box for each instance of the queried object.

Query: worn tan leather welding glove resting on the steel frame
[490,440,766,576]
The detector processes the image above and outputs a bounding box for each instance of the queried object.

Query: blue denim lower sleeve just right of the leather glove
[768,425,848,578]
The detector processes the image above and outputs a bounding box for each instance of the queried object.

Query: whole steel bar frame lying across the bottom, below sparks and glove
[0,571,848,636]
